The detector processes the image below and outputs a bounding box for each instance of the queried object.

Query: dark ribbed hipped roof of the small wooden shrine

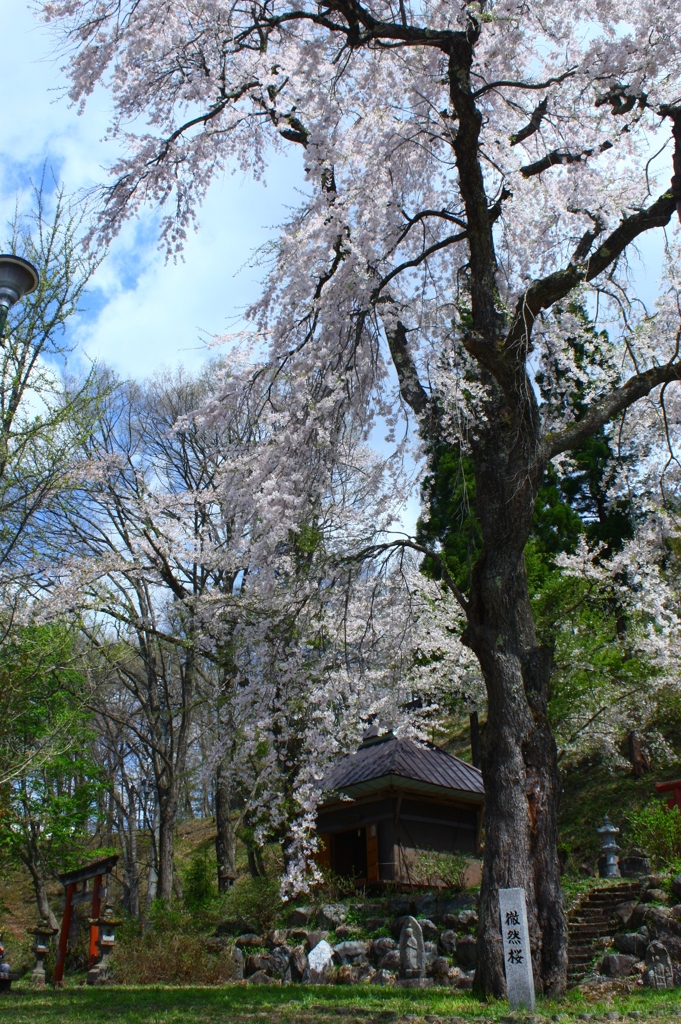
[322,730,484,803]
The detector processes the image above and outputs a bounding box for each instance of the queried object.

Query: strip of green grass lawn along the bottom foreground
[0,985,681,1024]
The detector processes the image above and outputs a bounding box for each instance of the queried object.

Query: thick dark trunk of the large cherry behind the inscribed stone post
[463,430,567,996]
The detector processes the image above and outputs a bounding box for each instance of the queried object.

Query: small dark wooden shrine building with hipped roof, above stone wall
[316,726,484,884]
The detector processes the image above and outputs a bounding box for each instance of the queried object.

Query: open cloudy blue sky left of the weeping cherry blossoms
[0,0,301,378]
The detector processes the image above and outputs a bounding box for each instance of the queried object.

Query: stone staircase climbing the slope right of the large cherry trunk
[567,882,641,985]
